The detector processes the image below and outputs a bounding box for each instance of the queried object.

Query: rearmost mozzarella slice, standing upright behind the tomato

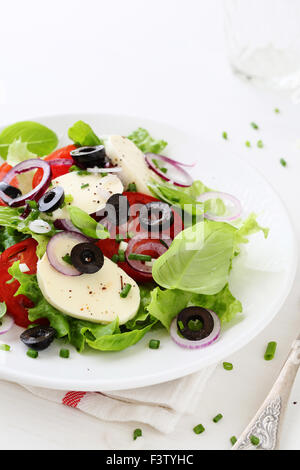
[104,135,156,195]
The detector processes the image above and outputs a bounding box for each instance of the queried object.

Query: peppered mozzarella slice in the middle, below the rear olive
[52,171,123,220]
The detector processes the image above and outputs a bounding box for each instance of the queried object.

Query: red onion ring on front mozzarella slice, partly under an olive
[46,231,90,276]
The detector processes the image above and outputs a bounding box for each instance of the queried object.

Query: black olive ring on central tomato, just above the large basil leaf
[139,201,174,232]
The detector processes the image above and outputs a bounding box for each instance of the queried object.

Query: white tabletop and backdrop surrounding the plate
[0,0,300,449]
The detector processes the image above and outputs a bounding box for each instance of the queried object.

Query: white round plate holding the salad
[0,114,297,391]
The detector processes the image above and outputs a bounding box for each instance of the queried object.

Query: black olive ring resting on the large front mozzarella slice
[71,243,104,274]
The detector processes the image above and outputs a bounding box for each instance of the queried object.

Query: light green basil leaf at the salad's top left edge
[0,121,58,159]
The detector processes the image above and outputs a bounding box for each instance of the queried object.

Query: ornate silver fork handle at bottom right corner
[232,335,300,450]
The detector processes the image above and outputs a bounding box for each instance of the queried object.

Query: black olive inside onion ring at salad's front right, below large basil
[177,307,214,341]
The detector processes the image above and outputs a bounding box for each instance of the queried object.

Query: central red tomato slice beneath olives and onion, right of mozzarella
[96,192,184,284]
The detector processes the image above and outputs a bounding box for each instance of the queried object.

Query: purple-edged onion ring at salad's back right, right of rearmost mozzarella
[145,153,195,188]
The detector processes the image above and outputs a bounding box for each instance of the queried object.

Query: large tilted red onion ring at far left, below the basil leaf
[0,158,51,207]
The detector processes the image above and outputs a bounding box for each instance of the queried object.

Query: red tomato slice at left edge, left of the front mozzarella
[0,238,38,328]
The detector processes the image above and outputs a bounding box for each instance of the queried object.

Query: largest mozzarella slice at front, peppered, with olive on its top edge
[37,253,140,324]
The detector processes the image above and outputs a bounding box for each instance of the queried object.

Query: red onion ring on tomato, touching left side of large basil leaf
[125,233,172,279]
